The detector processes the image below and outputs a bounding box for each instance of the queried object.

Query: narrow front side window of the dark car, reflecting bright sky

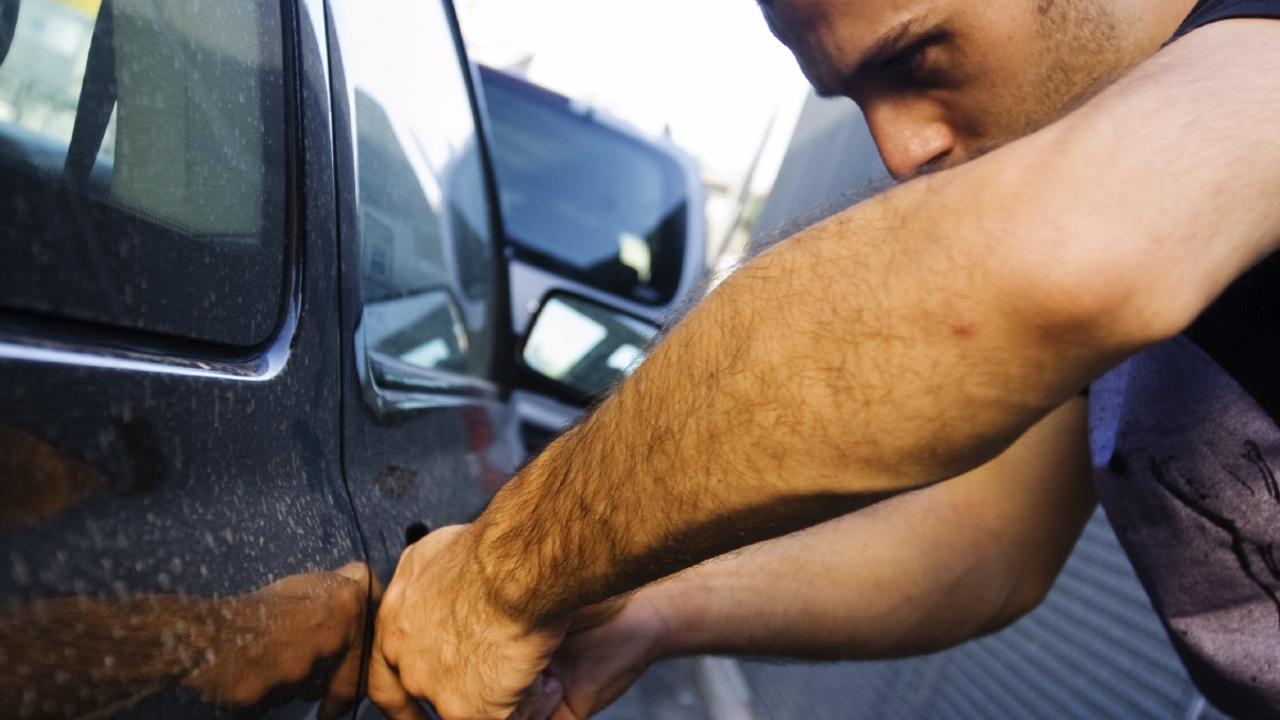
[334,0,495,382]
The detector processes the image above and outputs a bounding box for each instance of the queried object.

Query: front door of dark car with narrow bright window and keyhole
[330,0,521,594]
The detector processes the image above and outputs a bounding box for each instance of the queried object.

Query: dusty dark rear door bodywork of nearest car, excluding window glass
[0,3,367,717]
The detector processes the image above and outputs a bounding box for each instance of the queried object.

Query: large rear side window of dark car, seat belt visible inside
[0,0,287,346]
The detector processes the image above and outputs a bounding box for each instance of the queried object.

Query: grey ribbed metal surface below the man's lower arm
[744,512,1210,720]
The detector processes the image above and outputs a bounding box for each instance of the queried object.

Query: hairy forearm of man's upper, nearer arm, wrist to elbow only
[475,155,1117,620]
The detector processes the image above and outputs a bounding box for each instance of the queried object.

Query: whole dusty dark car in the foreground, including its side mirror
[0,0,700,717]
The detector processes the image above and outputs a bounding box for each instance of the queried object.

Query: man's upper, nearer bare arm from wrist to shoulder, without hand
[474,20,1280,623]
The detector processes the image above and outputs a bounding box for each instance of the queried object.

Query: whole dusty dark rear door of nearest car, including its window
[0,0,370,717]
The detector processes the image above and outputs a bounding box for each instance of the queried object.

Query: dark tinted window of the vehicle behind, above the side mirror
[484,65,689,304]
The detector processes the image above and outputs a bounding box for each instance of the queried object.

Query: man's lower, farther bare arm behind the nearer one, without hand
[636,400,1097,660]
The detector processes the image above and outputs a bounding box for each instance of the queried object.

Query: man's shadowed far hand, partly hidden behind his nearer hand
[534,591,669,720]
